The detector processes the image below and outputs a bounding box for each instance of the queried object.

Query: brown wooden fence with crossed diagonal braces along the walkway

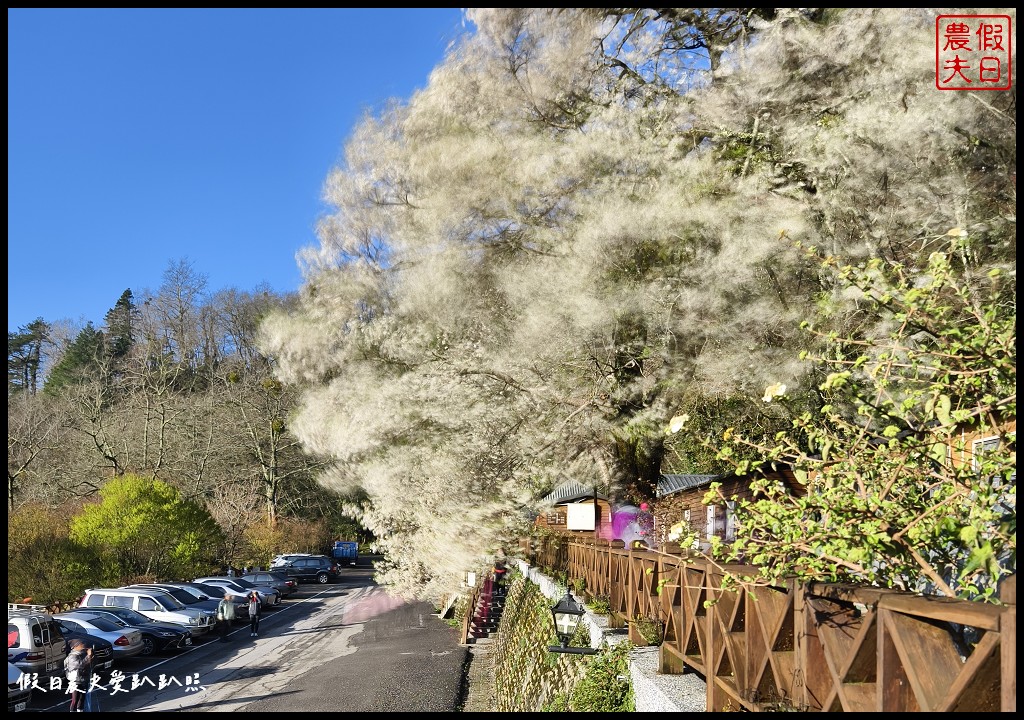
[530,534,1017,712]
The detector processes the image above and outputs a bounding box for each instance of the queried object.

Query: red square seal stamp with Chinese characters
[935,15,1014,90]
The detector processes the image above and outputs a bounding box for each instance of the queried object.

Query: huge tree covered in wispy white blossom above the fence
[263,8,1016,597]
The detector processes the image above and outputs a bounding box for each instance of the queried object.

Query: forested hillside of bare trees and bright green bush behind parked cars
[7,261,362,601]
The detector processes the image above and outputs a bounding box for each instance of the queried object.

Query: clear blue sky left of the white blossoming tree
[7,8,466,330]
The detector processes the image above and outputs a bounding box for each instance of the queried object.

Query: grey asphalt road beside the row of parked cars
[30,565,468,713]
